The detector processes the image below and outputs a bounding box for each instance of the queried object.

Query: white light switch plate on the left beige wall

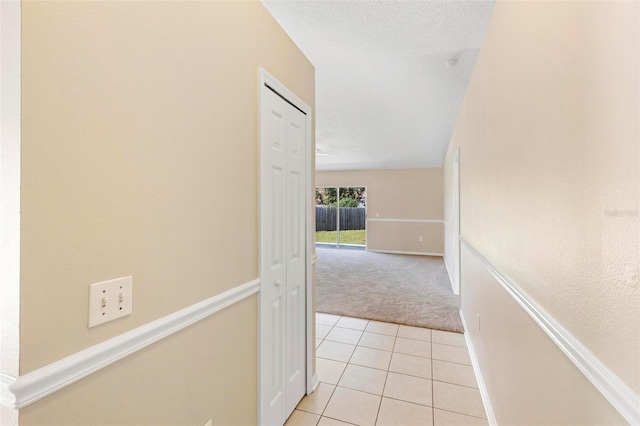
[89,276,133,328]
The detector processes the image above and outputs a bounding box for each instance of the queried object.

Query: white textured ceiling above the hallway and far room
[262,0,493,170]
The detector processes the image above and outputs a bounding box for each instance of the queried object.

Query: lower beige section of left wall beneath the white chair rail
[20,295,258,426]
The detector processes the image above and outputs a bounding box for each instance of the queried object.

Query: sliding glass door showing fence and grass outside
[315,186,367,249]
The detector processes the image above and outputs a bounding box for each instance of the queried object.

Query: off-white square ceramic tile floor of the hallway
[286,313,488,426]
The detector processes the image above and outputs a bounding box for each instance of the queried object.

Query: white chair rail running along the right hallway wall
[460,238,640,425]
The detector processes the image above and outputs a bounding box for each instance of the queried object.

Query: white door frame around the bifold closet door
[258,67,319,424]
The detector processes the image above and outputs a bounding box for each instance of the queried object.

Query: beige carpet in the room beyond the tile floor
[316,248,464,333]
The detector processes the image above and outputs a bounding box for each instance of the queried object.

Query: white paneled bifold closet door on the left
[260,87,306,425]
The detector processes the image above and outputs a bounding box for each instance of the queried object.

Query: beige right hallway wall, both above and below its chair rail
[445,2,640,424]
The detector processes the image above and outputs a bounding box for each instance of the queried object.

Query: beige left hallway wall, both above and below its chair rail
[20,2,315,425]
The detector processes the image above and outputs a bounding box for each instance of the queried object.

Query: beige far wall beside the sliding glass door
[316,168,444,254]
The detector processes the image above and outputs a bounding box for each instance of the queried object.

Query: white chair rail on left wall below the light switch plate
[2,279,260,409]
